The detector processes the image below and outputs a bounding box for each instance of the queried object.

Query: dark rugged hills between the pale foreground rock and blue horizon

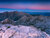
[0,11,50,34]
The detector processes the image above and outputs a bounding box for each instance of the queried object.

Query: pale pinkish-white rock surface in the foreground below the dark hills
[0,24,50,38]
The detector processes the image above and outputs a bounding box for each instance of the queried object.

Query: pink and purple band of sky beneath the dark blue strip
[0,4,50,10]
